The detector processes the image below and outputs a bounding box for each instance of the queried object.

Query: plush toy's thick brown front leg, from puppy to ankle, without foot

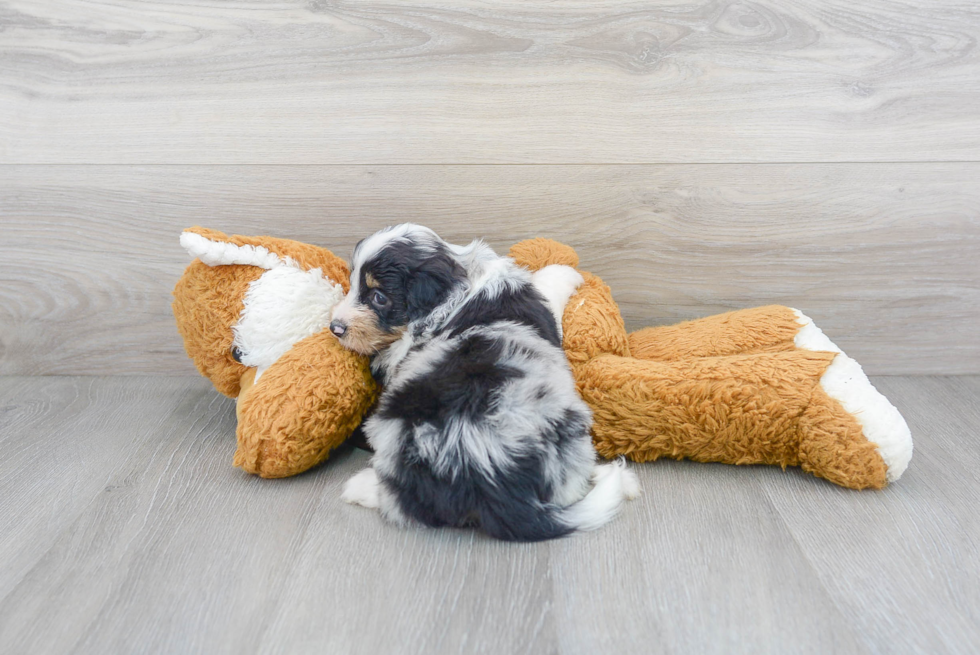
[578,351,833,466]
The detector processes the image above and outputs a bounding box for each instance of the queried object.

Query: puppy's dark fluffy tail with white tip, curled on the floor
[481,459,640,541]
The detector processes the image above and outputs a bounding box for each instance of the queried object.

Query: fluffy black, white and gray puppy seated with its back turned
[330,224,639,541]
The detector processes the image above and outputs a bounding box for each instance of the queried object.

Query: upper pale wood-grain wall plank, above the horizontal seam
[0,0,980,164]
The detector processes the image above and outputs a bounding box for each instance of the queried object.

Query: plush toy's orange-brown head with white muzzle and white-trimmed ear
[173,227,349,398]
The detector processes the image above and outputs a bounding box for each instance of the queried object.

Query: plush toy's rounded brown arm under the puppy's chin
[235,330,377,478]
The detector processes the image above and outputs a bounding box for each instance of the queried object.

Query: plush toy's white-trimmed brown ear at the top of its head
[180,227,350,293]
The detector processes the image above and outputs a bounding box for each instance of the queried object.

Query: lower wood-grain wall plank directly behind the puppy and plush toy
[0,164,980,374]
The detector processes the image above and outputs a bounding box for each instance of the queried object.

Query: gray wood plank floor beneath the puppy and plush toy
[0,377,980,654]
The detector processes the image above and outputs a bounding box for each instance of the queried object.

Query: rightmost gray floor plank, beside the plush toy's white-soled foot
[765,377,980,653]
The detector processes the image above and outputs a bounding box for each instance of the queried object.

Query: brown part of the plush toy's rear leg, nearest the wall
[629,305,803,361]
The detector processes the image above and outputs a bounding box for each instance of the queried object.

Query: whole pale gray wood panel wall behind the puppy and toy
[0,0,980,374]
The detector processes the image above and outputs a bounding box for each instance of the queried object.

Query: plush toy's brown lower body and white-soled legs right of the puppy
[510,239,912,489]
